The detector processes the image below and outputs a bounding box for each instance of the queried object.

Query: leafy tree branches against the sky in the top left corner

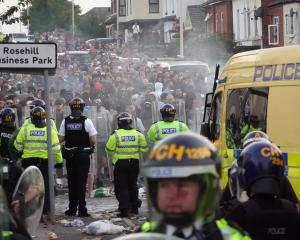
[0,0,31,24]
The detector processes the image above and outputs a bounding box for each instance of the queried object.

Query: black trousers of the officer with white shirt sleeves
[66,153,90,213]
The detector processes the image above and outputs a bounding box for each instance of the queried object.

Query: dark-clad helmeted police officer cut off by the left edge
[0,108,22,203]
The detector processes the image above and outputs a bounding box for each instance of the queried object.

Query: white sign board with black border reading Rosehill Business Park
[0,43,57,70]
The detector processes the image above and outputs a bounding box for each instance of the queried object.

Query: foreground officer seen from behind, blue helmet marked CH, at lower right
[226,142,300,240]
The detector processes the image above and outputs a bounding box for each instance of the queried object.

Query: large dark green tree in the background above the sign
[29,0,81,32]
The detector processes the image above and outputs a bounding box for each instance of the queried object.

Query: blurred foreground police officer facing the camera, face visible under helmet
[142,133,250,240]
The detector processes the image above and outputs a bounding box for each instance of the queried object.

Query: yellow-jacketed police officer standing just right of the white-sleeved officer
[106,112,148,217]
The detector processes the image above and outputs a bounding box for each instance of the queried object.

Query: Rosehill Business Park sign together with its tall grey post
[0,43,57,224]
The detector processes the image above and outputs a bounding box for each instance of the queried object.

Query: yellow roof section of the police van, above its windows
[220,45,300,83]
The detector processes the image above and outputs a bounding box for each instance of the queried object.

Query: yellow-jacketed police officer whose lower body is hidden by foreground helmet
[147,103,189,143]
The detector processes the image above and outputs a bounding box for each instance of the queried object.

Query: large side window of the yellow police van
[226,87,269,148]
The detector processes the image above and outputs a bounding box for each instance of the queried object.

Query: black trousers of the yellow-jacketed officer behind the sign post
[22,158,50,213]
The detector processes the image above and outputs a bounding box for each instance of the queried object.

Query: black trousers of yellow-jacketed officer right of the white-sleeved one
[114,159,140,211]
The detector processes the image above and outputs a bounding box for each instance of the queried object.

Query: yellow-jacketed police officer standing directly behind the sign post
[14,107,63,214]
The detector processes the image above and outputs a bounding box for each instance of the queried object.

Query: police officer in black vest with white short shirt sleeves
[58,97,97,217]
